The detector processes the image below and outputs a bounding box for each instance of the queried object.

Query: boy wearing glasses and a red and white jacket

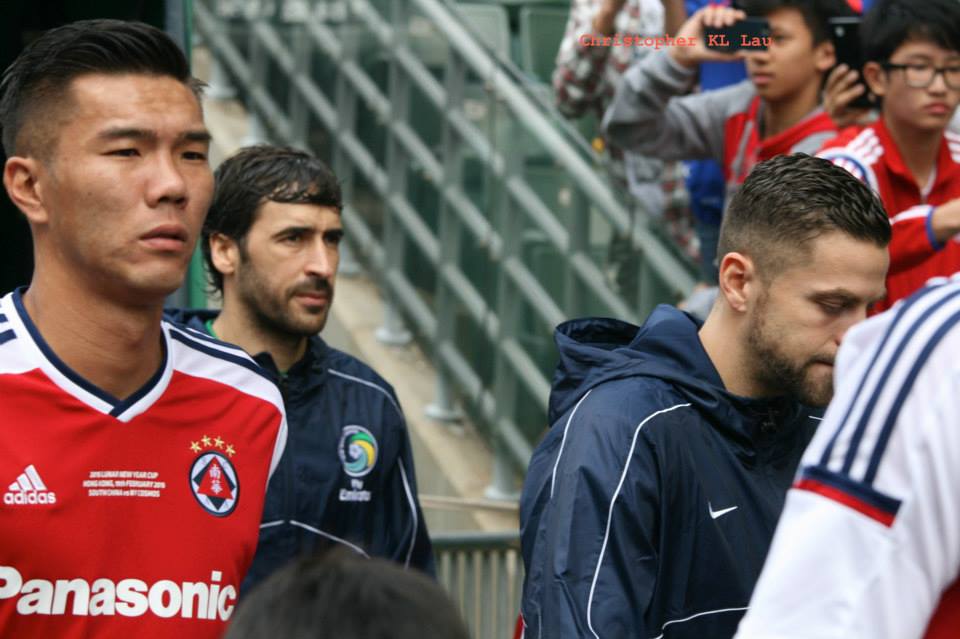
[820,0,960,312]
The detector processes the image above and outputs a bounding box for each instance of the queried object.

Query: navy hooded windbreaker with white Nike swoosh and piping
[520,306,821,639]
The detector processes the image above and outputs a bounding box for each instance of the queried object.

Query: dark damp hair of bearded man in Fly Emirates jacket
[200,144,343,292]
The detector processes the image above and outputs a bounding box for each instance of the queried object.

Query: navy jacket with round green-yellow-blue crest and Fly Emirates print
[172,310,434,593]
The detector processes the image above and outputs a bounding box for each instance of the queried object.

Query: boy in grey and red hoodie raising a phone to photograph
[604,0,853,268]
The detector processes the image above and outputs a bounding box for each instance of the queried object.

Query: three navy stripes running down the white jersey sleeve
[820,283,960,477]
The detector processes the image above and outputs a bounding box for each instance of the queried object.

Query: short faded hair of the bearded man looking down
[718,153,891,281]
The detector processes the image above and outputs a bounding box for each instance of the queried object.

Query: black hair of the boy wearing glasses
[860,0,960,62]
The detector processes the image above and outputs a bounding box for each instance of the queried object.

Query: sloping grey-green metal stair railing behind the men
[193,0,694,495]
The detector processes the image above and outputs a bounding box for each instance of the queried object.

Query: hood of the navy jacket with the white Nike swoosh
[548,305,803,440]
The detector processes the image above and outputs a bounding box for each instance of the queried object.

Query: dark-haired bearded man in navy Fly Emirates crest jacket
[174,146,434,592]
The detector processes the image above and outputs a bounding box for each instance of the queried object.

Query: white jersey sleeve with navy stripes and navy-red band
[737,278,960,639]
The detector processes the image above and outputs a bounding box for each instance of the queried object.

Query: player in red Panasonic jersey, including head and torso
[0,20,286,639]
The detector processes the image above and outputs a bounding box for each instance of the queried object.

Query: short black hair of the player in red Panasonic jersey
[0,19,203,156]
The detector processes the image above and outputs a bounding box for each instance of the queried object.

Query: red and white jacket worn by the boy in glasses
[817,118,960,312]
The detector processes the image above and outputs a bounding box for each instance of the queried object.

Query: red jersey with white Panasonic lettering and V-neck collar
[0,292,286,639]
